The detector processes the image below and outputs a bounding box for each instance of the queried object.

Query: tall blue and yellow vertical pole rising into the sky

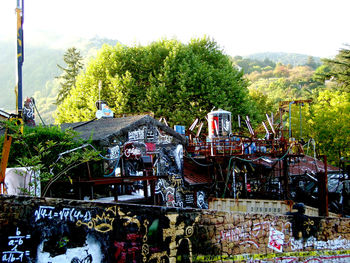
[16,0,24,116]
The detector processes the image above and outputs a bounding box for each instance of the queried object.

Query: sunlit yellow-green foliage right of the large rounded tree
[246,46,350,165]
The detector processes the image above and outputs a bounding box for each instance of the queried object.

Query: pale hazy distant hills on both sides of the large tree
[0,40,320,123]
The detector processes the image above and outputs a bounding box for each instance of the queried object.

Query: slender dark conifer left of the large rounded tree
[56,47,83,105]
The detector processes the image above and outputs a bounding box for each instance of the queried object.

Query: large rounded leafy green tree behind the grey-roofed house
[56,38,251,125]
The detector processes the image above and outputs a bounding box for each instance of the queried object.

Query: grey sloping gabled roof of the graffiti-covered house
[61,115,186,146]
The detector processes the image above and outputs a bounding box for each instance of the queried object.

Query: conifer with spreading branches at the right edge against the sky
[323,45,350,92]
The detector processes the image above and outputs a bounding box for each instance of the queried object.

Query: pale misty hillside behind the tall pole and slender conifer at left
[0,37,118,111]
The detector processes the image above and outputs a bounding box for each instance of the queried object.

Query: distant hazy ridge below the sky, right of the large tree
[245,52,322,66]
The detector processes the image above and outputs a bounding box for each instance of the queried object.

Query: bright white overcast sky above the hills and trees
[0,0,350,57]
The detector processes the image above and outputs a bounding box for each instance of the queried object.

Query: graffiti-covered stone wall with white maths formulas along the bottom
[0,196,350,263]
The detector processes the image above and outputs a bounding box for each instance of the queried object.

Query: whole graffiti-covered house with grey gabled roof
[58,115,193,207]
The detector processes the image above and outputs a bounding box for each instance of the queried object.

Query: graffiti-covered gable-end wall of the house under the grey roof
[106,125,191,207]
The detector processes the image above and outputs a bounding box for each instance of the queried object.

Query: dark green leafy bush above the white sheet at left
[0,121,98,196]
